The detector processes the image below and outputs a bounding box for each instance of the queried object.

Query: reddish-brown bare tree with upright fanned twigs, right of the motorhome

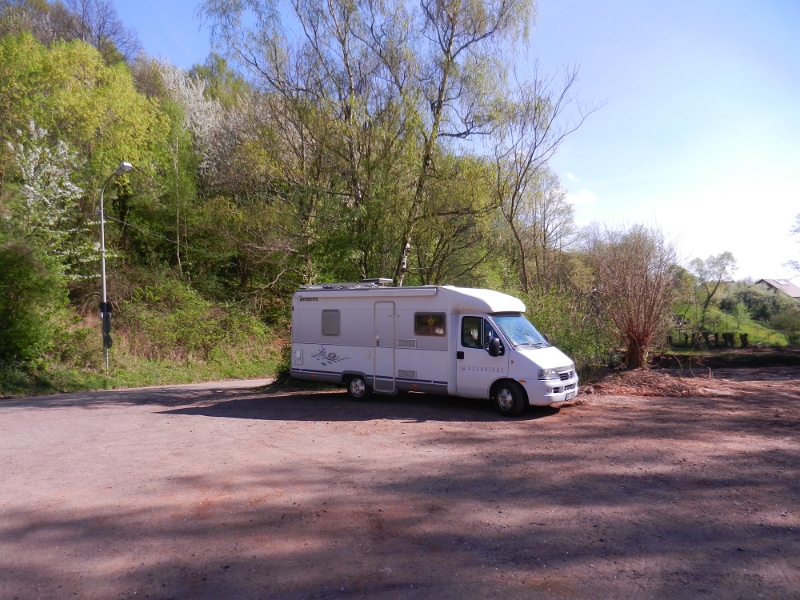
[588,225,678,369]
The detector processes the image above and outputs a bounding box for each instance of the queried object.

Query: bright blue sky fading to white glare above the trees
[114,0,800,282]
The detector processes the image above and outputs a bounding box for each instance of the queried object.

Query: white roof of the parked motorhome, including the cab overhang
[296,283,525,313]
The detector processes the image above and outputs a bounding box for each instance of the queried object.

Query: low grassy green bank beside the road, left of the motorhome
[0,280,285,396]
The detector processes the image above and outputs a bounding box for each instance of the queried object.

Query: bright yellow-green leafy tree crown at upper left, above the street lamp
[0,32,168,193]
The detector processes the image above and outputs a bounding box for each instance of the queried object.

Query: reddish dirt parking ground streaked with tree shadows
[0,368,800,600]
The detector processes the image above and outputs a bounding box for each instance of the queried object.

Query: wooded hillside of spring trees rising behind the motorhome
[0,0,800,393]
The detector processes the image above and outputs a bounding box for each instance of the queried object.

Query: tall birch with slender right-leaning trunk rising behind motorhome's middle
[384,0,534,285]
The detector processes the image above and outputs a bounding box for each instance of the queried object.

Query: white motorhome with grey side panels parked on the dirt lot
[291,279,578,415]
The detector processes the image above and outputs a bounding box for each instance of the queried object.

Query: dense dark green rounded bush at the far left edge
[0,242,66,362]
